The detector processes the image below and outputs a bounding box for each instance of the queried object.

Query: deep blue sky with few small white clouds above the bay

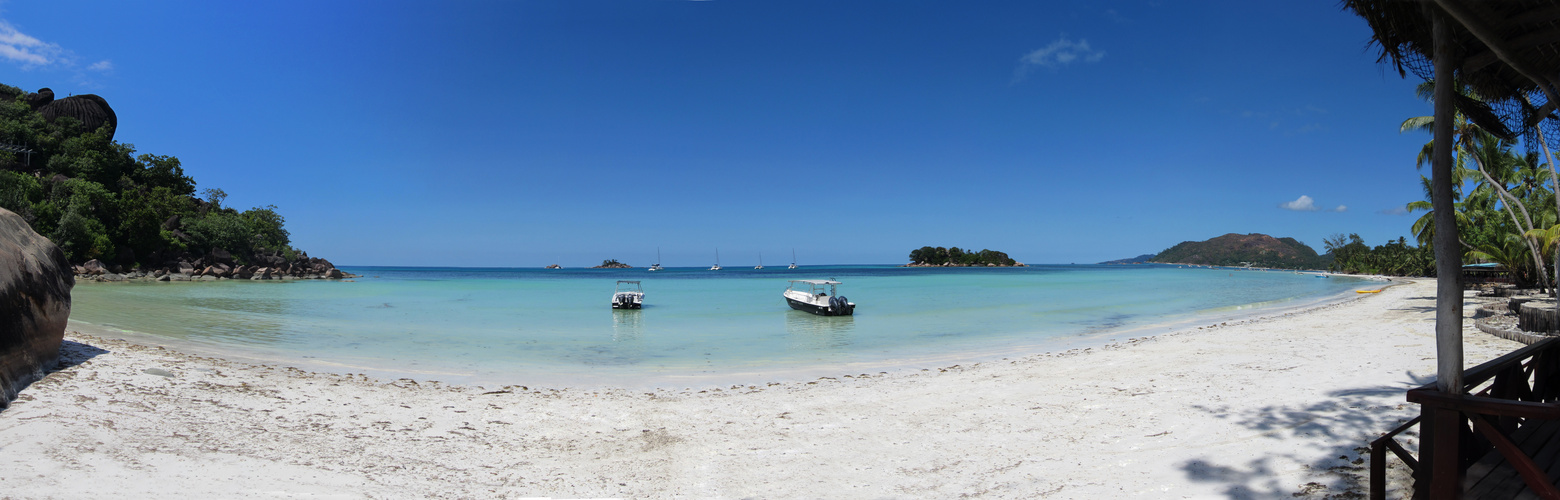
[0,0,1431,266]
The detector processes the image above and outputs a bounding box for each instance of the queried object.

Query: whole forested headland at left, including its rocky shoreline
[0,84,346,280]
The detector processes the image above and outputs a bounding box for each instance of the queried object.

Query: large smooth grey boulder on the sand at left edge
[0,209,76,408]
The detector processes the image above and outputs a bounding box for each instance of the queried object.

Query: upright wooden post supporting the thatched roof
[1431,16,1463,394]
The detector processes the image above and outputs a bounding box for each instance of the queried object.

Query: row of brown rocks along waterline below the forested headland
[72,249,359,282]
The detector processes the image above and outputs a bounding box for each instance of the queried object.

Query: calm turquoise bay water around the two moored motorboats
[72,265,1373,385]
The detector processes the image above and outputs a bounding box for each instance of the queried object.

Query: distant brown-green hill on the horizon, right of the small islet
[1153,232,1326,269]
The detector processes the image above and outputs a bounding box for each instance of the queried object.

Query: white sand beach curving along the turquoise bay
[0,280,1519,498]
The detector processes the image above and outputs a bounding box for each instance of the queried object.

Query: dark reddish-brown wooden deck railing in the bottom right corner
[1370,338,1560,500]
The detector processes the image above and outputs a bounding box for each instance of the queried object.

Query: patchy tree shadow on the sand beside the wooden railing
[1181,374,1434,500]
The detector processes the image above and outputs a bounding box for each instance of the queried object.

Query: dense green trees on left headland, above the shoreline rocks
[0,84,298,266]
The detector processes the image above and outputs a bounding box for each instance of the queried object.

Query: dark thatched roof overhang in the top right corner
[1343,0,1560,146]
